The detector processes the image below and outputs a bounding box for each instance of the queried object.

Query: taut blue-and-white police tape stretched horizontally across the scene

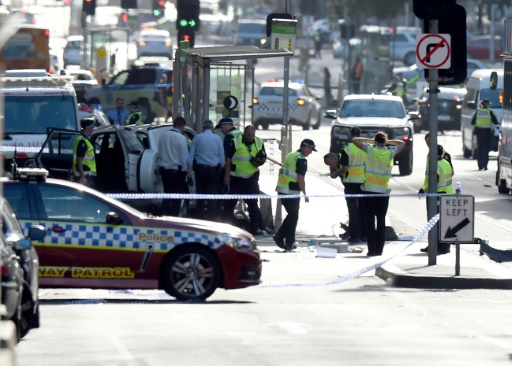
[107,193,446,200]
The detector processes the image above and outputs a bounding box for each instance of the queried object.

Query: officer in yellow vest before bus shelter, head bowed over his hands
[224,125,266,235]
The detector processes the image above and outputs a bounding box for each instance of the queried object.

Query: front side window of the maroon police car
[38,184,111,223]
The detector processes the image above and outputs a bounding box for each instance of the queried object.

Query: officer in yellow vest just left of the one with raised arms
[324,127,368,244]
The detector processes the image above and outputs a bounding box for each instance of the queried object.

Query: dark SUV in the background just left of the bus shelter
[85,62,173,123]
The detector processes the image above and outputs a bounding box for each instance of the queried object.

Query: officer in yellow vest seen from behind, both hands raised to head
[352,131,405,256]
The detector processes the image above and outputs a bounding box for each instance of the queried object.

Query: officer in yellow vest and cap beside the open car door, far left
[73,118,96,187]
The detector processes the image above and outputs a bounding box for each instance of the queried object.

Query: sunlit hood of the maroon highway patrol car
[144,216,252,239]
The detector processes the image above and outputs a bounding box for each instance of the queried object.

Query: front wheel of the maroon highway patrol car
[162,246,221,300]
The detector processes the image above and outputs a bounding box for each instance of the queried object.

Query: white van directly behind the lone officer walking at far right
[460,69,503,159]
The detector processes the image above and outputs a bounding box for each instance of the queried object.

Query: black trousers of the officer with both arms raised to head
[361,192,389,255]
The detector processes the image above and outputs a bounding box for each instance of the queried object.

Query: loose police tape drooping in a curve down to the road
[258,214,439,288]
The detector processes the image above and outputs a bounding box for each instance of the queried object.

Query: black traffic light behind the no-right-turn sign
[423,4,468,85]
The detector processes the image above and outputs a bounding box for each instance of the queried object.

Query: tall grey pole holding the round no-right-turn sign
[425,20,439,266]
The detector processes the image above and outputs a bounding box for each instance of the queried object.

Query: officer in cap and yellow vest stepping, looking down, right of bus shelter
[273,139,317,252]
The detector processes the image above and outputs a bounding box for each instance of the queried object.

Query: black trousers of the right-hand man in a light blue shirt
[194,164,220,221]
